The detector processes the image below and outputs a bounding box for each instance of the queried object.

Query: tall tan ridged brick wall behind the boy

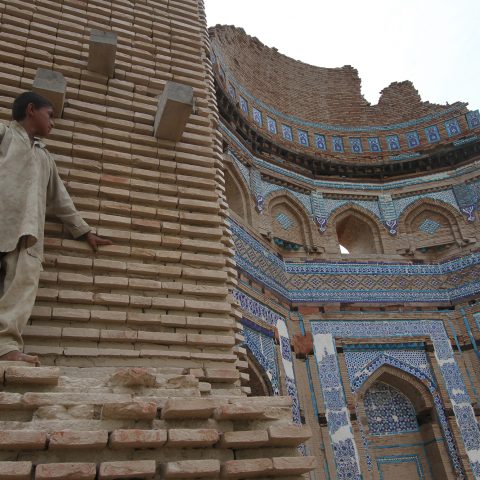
[0,0,246,382]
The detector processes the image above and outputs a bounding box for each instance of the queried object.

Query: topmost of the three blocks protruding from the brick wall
[88,30,117,77]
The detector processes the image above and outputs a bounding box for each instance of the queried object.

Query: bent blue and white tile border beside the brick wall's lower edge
[233,290,302,424]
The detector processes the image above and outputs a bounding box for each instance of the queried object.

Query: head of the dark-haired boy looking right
[12,92,54,137]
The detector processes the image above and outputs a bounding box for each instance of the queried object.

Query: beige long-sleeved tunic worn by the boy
[0,122,90,260]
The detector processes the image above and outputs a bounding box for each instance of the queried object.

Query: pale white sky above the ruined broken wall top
[205,0,480,110]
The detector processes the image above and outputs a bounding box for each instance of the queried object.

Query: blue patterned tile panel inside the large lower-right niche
[364,382,418,435]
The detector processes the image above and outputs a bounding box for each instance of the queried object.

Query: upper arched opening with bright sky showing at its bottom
[330,204,383,255]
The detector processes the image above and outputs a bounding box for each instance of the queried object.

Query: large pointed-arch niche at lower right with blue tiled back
[355,364,456,480]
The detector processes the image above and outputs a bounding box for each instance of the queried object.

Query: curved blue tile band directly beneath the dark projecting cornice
[220,123,478,192]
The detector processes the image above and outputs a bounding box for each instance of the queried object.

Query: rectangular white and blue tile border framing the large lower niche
[311,320,480,480]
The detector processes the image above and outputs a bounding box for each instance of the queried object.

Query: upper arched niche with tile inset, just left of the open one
[266,190,313,254]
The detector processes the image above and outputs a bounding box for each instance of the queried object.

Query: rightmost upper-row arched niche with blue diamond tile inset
[399,199,465,260]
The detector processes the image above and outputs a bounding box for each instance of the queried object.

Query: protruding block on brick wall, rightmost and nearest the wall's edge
[154,82,193,142]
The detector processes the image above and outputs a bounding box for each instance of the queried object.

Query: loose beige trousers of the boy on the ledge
[0,239,42,356]
